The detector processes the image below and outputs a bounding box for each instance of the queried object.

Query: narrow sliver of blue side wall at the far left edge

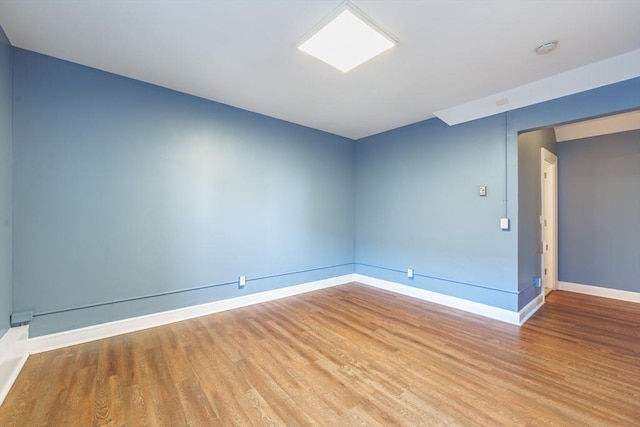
[0,27,13,337]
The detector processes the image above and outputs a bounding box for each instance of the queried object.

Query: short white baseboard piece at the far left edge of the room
[0,326,29,405]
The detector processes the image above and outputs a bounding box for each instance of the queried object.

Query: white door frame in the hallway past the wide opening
[540,147,558,298]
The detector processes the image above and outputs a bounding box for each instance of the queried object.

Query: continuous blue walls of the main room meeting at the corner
[0,29,640,336]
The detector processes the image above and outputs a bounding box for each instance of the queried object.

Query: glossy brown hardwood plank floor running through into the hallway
[0,284,640,427]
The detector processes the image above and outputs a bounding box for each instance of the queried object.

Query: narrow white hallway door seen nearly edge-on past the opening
[540,148,558,294]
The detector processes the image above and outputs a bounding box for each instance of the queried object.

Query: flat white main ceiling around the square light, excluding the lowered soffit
[0,0,640,139]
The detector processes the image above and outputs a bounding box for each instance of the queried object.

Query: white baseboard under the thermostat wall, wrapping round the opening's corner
[354,273,542,326]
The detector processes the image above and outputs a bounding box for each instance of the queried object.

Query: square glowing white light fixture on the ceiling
[298,5,396,73]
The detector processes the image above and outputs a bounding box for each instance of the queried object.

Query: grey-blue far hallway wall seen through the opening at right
[558,131,640,292]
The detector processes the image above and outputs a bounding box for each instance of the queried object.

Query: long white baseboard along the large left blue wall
[27,274,353,354]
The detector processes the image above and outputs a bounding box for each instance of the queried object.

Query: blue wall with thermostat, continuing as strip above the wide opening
[355,78,640,311]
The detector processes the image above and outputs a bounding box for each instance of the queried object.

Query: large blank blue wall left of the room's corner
[13,49,354,335]
